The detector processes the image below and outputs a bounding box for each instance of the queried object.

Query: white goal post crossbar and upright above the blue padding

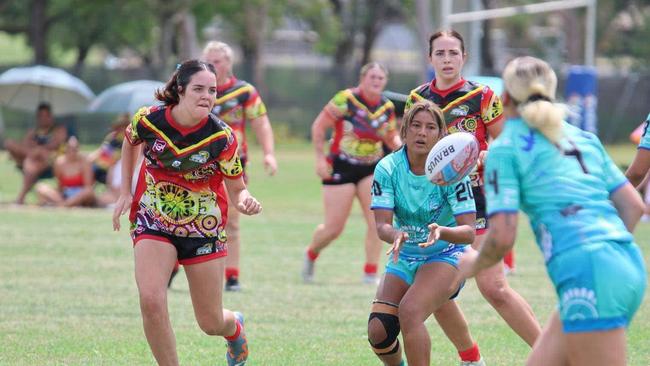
[440,0,598,66]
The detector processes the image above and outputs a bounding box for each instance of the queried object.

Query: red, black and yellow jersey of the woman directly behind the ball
[406,79,503,185]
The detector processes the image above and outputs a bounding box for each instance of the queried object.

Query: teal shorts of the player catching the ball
[386,244,466,286]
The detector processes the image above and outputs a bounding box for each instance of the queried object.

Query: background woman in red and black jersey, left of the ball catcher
[302,62,401,284]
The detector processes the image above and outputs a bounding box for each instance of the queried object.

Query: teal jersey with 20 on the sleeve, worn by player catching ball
[371,147,476,258]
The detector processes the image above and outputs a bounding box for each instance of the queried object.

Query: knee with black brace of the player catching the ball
[368,301,400,356]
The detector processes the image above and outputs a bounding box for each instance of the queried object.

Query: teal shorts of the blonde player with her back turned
[548,242,646,333]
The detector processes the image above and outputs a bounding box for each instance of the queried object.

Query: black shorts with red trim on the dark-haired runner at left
[131,225,228,265]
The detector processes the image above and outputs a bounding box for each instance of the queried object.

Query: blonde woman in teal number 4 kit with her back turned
[460,57,646,366]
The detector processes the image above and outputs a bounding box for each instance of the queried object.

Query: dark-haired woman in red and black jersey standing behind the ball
[406,30,541,346]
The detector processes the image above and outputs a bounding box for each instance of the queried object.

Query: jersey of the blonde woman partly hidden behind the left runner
[212,76,266,159]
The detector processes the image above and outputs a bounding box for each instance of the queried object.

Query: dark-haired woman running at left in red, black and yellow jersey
[113,60,262,365]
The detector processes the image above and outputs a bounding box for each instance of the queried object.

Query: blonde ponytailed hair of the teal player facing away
[503,56,564,144]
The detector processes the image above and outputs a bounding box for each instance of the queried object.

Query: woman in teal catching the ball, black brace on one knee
[368,101,483,366]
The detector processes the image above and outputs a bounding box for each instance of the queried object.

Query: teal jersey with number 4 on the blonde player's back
[485,119,632,262]
